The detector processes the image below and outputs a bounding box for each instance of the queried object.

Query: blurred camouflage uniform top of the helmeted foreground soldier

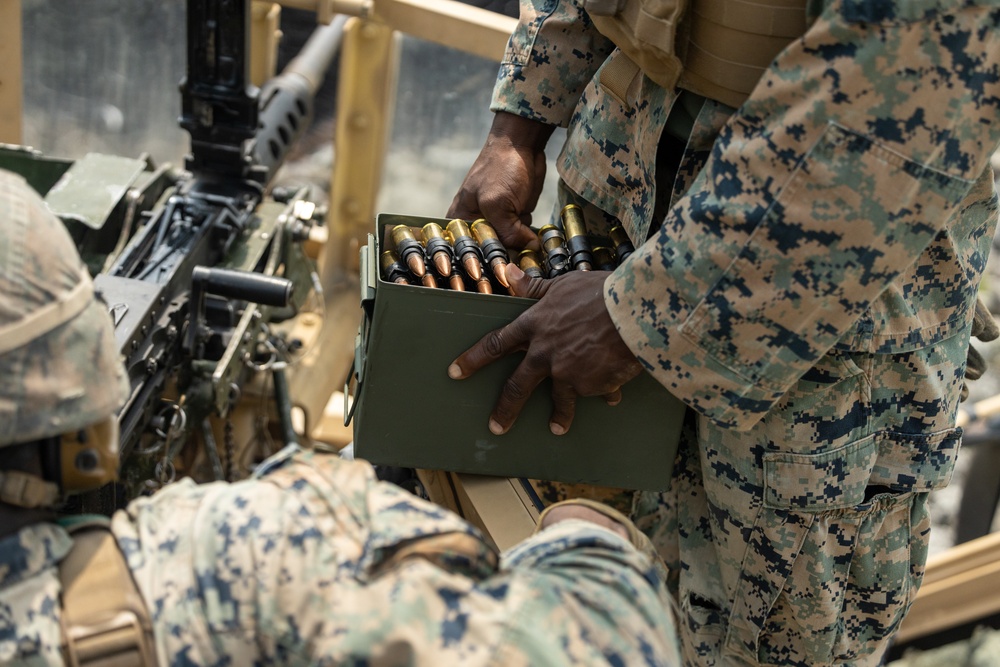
[0,449,679,667]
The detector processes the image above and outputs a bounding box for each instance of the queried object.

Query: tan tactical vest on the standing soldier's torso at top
[583,0,807,107]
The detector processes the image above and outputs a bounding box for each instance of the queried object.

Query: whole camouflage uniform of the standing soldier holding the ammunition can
[493,0,1000,667]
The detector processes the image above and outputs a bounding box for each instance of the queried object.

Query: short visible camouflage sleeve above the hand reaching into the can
[490,0,614,127]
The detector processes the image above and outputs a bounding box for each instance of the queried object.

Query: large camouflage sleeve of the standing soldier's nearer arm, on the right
[605,0,1000,429]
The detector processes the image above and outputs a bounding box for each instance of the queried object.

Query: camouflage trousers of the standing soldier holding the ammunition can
[535,68,997,667]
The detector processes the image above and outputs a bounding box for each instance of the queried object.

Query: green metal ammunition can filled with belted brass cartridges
[345,214,685,490]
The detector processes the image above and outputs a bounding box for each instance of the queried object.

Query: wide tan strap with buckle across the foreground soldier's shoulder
[59,521,157,667]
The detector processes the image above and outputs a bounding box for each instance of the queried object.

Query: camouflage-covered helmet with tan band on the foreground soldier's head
[0,170,129,447]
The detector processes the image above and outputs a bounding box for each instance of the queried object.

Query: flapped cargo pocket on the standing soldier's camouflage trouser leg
[726,429,960,667]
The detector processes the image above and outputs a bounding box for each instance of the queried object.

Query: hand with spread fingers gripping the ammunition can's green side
[448,264,642,435]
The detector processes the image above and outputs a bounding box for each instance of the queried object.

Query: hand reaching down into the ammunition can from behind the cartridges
[447,112,555,250]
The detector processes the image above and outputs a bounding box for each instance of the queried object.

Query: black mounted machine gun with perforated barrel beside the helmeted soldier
[0,0,342,513]
